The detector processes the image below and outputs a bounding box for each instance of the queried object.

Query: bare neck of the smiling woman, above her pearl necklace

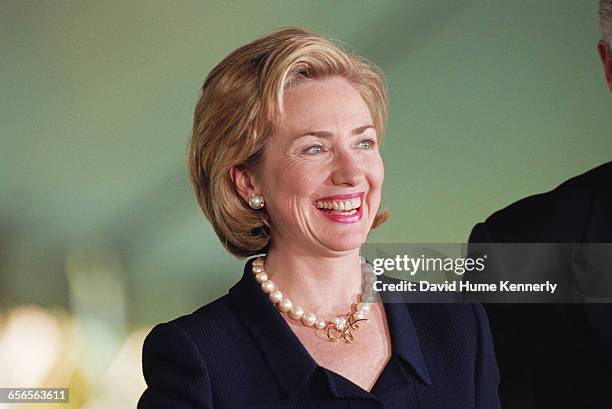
[265,241,361,319]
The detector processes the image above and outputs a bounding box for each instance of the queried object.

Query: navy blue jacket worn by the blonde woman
[138,261,500,409]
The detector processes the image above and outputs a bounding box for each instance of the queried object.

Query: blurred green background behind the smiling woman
[0,0,612,408]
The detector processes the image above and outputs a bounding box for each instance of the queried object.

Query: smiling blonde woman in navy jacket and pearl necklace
[138,28,499,409]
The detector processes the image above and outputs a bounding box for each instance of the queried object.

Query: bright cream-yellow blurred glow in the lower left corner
[0,305,150,409]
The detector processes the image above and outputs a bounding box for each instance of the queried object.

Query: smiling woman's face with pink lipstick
[259,77,384,253]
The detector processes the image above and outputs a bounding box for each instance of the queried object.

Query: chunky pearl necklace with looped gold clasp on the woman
[252,257,371,344]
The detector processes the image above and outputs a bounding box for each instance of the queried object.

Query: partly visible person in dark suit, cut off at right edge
[469,0,612,409]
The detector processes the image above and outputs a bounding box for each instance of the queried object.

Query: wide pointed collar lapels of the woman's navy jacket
[229,259,431,397]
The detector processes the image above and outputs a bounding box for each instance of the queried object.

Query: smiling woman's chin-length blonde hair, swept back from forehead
[187,27,388,257]
